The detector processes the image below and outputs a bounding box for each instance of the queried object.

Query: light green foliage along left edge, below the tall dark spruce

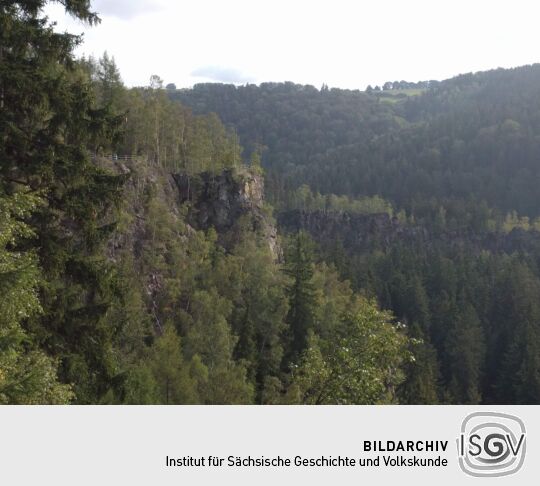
[0,192,73,405]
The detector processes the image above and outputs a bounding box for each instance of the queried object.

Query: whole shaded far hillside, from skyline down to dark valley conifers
[177,65,540,403]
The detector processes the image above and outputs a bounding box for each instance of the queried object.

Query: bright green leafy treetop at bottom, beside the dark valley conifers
[288,300,410,404]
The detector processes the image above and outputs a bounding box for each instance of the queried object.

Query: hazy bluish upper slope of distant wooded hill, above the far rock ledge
[176,65,540,218]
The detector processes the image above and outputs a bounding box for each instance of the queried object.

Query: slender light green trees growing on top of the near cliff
[89,74,241,176]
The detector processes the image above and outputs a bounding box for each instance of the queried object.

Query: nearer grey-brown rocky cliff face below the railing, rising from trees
[100,159,281,333]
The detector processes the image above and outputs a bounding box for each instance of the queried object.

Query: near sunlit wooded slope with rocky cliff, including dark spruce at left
[0,0,413,404]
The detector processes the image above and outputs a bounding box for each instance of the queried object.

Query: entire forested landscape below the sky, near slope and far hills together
[0,0,540,404]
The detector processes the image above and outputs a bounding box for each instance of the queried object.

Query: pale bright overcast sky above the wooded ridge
[47,0,540,89]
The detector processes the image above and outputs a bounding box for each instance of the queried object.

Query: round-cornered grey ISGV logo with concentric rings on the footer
[457,412,527,477]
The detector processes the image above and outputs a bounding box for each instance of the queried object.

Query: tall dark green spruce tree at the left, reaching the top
[0,0,123,403]
